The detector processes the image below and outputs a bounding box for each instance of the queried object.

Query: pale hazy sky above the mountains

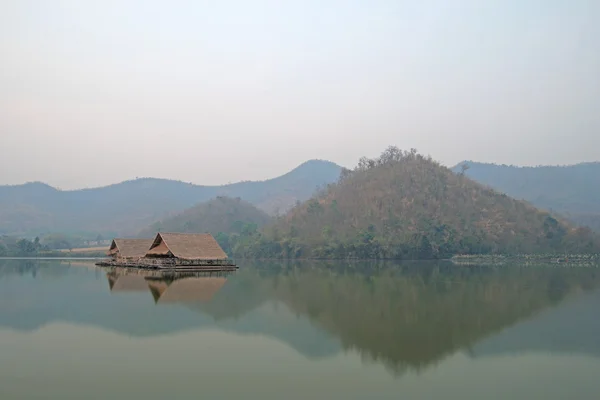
[0,0,600,189]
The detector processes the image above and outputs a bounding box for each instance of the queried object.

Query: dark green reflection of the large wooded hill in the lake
[250,264,600,372]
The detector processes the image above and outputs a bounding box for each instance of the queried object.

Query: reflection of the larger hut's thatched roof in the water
[148,277,227,303]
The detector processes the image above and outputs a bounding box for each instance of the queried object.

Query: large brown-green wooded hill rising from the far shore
[237,147,599,258]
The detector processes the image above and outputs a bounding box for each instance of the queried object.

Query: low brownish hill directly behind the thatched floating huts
[140,197,271,237]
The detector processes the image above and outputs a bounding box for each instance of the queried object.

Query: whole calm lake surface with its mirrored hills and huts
[0,260,600,400]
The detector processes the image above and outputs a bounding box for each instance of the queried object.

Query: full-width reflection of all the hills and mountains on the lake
[0,263,600,373]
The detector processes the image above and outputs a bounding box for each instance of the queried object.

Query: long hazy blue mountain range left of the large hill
[0,160,341,235]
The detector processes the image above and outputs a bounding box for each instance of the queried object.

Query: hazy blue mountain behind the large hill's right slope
[453,161,600,231]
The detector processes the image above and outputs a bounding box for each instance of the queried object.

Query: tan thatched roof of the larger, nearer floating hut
[146,232,227,260]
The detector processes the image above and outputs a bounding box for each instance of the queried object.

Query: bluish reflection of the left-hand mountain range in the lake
[0,260,341,357]
